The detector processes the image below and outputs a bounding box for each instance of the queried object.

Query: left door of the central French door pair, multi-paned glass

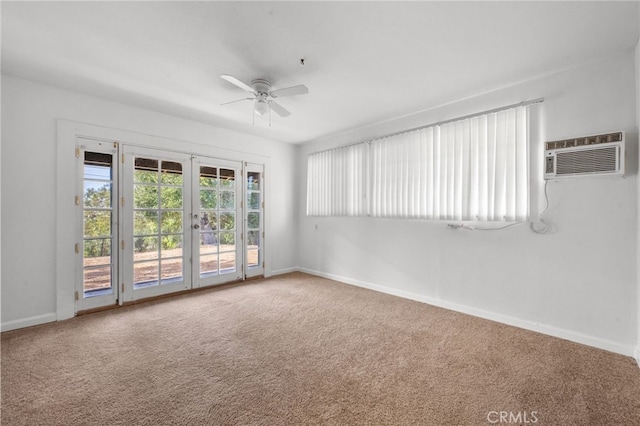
[120,146,191,302]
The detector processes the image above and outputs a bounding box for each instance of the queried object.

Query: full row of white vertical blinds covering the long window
[307,106,529,222]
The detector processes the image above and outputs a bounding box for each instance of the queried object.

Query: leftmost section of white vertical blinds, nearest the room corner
[307,143,368,216]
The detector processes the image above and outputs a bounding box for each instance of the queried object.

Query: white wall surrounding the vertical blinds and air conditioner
[298,52,638,355]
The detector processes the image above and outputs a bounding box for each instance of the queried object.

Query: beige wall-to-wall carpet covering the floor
[2,273,640,425]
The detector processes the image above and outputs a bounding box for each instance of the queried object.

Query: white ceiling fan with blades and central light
[220,74,309,124]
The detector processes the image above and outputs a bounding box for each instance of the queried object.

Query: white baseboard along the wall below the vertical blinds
[299,268,640,358]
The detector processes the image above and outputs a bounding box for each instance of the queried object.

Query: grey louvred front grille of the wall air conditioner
[556,146,618,176]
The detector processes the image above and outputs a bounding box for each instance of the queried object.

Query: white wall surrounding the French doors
[0,75,297,330]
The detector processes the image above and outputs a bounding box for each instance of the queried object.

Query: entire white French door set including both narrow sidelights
[76,141,264,310]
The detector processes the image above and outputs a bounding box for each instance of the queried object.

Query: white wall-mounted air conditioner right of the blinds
[544,132,624,179]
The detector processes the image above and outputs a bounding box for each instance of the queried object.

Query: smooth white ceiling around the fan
[1,1,640,143]
